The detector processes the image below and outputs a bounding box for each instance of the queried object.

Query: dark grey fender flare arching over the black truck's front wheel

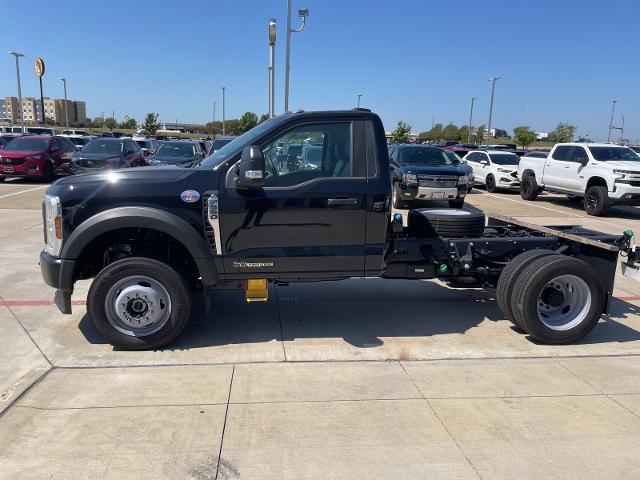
[60,207,218,285]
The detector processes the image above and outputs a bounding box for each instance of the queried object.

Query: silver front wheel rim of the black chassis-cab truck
[105,275,171,337]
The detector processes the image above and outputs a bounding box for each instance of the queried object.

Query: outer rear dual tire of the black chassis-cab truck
[511,255,605,344]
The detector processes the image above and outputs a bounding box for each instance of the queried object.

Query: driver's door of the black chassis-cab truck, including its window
[219,117,367,278]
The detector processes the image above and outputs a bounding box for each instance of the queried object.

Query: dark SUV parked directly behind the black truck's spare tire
[389,144,471,208]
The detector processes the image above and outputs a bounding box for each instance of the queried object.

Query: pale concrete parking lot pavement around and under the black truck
[0,181,640,480]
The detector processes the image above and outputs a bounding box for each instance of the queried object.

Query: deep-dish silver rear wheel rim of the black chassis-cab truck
[537,275,591,331]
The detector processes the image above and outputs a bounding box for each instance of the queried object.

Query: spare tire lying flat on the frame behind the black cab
[407,208,485,238]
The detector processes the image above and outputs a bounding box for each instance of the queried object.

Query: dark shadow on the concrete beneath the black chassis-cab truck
[79,279,640,350]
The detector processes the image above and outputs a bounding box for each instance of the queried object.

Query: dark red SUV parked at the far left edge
[0,135,76,182]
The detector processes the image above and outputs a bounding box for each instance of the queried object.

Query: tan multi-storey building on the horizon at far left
[0,97,87,125]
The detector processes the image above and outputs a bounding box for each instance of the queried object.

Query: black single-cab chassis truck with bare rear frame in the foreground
[40,109,638,349]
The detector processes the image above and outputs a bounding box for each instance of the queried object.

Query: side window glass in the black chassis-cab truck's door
[262,122,353,187]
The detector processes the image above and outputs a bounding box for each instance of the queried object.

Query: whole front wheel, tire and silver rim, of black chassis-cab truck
[87,257,191,350]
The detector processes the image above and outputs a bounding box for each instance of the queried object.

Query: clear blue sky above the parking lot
[0,0,640,140]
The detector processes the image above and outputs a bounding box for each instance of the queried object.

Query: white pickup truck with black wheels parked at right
[518,143,640,215]
